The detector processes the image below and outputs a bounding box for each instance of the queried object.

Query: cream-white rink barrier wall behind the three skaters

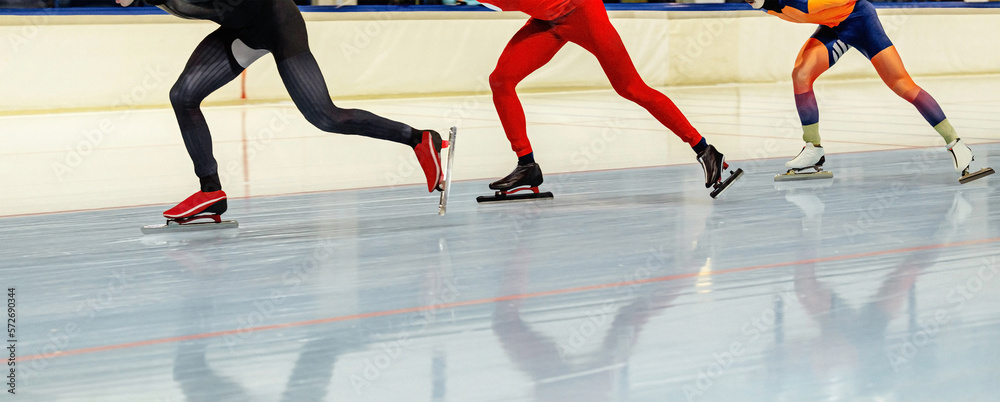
[0,8,1000,113]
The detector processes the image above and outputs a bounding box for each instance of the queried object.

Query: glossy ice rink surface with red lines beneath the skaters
[0,77,1000,402]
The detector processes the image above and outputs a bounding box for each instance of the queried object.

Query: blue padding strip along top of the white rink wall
[0,1,1000,16]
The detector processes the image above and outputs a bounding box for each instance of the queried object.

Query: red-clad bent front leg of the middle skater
[490,19,566,160]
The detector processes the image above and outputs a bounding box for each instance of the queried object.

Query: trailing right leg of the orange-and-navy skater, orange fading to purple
[872,47,958,143]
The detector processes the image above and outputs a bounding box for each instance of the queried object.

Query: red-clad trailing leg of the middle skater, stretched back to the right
[558,0,702,151]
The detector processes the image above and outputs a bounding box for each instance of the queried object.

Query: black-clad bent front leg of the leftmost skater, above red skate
[170,28,243,191]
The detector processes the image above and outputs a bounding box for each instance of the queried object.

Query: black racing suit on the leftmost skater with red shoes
[147,0,420,191]
